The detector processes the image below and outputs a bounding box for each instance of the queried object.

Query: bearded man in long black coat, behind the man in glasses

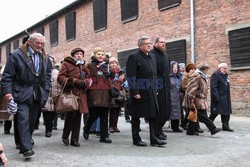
[150,37,171,140]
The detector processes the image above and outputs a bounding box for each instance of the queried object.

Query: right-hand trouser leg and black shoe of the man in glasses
[148,118,167,146]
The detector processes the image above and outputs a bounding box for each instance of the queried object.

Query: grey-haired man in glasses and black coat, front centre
[126,36,166,146]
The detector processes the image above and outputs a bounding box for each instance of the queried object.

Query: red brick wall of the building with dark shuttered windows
[2,0,250,115]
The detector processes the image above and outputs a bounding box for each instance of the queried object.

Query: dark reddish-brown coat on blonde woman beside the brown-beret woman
[87,57,111,107]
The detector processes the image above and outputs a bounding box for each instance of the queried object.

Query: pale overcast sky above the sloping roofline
[0,0,75,42]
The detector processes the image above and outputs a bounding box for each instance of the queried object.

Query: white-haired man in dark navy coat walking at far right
[209,63,234,132]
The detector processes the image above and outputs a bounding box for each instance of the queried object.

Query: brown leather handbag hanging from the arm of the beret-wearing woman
[56,78,79,113]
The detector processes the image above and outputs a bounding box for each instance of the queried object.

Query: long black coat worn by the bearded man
[151,47,171,123]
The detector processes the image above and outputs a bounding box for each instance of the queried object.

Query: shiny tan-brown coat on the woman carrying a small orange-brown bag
[183,71,208,110]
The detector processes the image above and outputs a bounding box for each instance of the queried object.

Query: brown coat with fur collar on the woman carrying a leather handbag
[57,57,89,113]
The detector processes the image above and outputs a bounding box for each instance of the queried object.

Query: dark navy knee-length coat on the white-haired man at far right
[210,70,232,115]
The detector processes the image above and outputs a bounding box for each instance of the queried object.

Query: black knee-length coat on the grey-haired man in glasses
[126,50,159,118]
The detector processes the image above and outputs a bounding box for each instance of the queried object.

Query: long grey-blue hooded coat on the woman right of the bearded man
[170,61,182,120]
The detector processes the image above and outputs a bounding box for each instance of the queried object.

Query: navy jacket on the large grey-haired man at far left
[1,45,52,107]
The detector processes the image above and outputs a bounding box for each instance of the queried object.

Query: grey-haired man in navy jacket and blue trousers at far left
[1,33,51,158]
